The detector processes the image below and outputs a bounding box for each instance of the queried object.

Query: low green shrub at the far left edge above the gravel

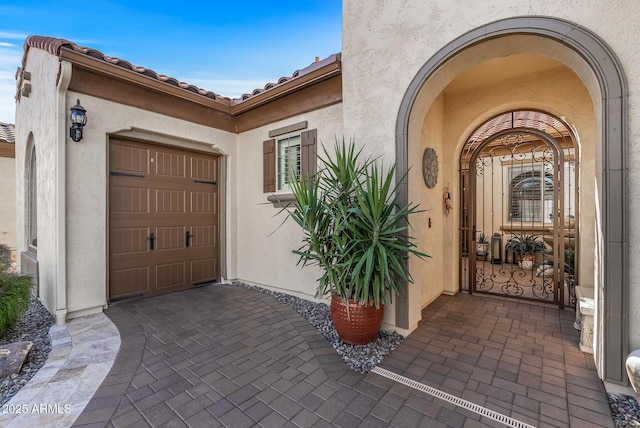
[0,244,31,336]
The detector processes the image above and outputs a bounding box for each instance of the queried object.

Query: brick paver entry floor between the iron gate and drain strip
[376,294,614,428]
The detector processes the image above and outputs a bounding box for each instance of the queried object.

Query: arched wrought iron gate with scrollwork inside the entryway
[460,111,578,308]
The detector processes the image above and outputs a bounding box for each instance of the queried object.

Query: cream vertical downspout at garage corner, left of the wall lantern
[55,61,72,325]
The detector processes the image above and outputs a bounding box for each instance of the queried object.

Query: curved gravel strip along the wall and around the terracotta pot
[233,282,404,373]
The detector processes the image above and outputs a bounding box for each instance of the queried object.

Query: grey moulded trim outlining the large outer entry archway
[396,16,629,384]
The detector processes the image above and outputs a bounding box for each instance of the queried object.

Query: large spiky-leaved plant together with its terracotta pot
[287,141,428,345]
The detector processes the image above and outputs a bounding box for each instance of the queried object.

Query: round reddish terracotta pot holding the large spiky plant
[331,295,384,345]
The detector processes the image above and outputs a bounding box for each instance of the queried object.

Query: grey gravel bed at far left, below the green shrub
[0,297,54,405]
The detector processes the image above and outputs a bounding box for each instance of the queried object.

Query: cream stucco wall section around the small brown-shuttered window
[236,104,342,299]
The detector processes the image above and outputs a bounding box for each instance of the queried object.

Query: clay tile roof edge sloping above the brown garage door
[23,36,229,100]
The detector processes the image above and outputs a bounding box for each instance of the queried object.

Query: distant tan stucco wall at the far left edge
[0,157,16,250]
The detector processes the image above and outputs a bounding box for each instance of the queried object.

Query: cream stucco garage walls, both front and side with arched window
[16,48,237,322]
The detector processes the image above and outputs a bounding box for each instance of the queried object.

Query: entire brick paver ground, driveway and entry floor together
[70,285,613,427]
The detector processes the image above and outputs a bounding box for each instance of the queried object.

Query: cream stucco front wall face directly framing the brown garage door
[66,92,236,317]
